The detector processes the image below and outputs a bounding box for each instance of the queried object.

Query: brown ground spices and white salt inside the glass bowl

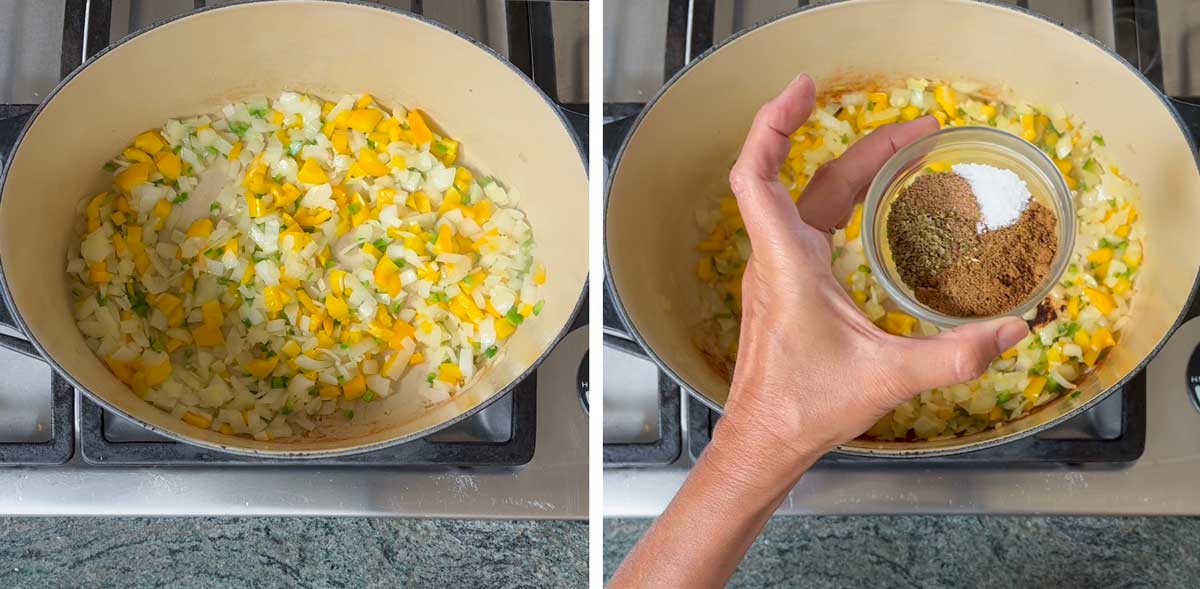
[887,163,1058,317]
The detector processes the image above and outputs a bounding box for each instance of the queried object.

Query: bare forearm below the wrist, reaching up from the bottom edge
[611,417,815,587]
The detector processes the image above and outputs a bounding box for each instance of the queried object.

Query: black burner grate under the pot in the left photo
[0,0,588,468]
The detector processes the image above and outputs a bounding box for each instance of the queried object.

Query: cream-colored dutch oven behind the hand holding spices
[605,0,1200,457]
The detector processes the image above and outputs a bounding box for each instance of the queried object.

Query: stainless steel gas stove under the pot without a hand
[0,0,588,518]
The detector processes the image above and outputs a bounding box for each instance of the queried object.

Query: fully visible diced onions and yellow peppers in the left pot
[67,92,546,440]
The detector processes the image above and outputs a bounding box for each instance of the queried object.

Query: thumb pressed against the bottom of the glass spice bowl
[892,317,1030,399]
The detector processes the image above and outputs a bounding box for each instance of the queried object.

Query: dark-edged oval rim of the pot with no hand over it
[0,0,588,461]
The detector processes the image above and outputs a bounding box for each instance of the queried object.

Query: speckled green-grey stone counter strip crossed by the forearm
[604,516,1200,589]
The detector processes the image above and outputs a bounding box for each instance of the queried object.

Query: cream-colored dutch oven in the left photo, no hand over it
[0,0,588,458]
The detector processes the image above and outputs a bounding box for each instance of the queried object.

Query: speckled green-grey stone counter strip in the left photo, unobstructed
[0,518,588,589]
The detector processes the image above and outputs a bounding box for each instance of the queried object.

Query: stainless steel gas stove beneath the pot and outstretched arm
[604,0,1200,517]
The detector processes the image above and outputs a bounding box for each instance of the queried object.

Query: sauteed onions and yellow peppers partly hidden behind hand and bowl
[696,79,1144,439]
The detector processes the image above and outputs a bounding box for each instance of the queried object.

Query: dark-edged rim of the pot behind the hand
[604,0,1200,458]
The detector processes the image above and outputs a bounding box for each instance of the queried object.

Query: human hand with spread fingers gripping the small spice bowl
[718,76,1028,476]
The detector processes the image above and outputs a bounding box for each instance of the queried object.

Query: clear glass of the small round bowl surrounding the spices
[863,127,1075,327]
